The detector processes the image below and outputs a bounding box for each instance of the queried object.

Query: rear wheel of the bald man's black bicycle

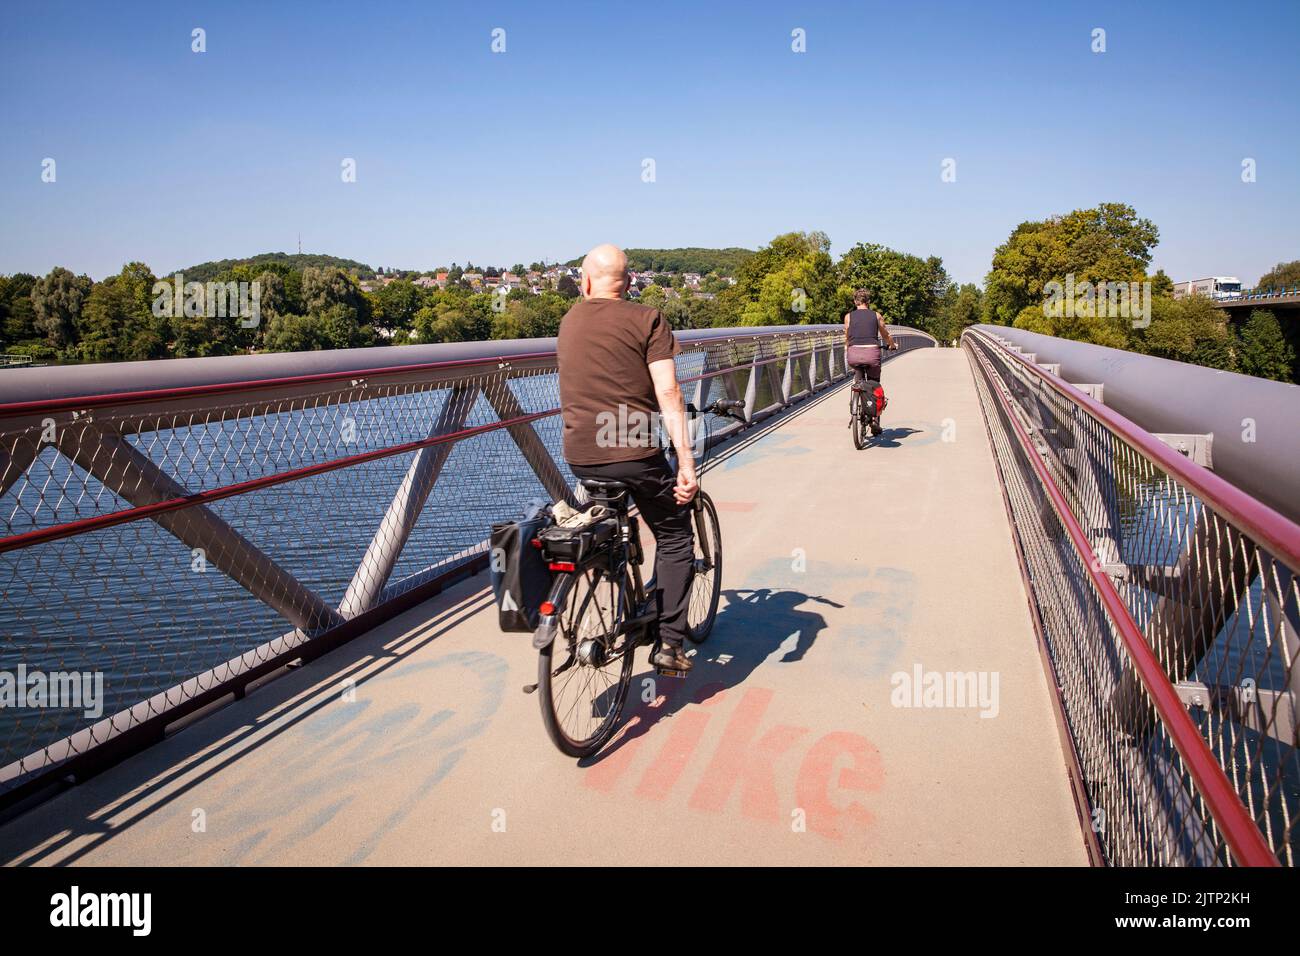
[537,568,636,757]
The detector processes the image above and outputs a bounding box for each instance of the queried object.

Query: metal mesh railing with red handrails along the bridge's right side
[963,330,1300,865]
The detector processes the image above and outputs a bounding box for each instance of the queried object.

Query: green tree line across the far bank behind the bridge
[0,210,1300,381]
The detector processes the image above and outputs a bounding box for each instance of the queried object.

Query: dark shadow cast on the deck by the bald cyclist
[579,588,844,766]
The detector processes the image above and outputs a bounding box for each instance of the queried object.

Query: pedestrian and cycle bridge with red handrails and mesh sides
[0,326,1300,866]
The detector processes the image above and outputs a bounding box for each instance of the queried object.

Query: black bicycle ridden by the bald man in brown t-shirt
[533,399,745,757]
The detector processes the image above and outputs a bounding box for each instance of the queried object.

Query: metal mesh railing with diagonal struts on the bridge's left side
[0,326,935,800]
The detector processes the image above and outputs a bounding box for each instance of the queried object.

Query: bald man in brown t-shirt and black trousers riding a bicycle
[556,246,699,670]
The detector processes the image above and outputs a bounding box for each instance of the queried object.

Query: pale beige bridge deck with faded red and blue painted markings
[0,349,1086,865]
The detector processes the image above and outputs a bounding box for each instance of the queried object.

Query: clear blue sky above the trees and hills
[0,0,1300,282]
